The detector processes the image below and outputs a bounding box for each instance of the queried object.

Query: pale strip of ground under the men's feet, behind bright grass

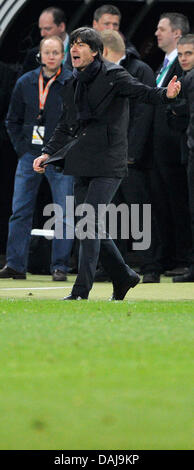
[0,275,194,301]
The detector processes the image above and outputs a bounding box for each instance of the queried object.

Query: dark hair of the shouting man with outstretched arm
[69,26,103,57]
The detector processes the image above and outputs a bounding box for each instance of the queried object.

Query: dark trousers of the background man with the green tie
[150,165,191,272]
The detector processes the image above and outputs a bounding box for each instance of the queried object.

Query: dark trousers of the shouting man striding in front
[72,177,136,297]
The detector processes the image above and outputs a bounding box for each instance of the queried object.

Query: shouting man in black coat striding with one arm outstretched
[34,28,180,300]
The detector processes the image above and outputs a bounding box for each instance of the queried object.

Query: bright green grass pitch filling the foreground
[0,290,194,450]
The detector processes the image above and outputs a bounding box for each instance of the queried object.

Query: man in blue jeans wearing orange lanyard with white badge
[0,36,73,281]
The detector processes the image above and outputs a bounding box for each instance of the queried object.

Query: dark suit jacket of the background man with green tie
[153,58,182,167]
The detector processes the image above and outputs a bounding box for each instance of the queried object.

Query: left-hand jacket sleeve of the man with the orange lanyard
[5,79,25,155]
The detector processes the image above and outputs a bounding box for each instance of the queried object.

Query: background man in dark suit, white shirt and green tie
[143,13,191,282]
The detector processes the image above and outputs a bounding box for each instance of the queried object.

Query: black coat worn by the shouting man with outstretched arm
[43,61,169,178]
